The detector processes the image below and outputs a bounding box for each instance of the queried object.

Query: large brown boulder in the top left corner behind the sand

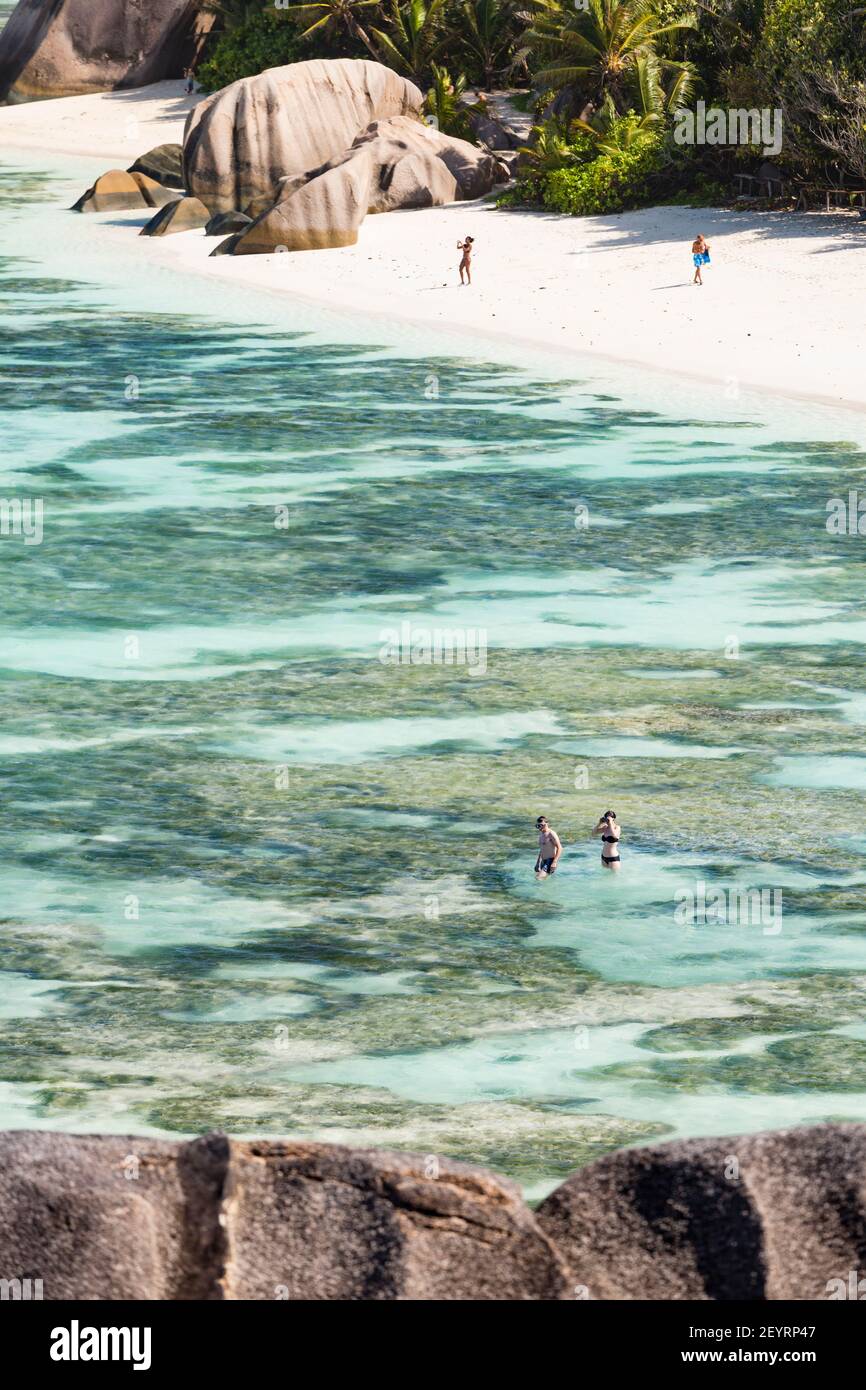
[0,0,213,101]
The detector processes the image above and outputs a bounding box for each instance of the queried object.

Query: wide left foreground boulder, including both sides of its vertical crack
[0,1131,566,1301]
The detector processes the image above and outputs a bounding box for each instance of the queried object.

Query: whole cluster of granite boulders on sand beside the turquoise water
[75,58,509,256]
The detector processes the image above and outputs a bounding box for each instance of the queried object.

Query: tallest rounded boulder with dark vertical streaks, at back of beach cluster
[183,58,423,213]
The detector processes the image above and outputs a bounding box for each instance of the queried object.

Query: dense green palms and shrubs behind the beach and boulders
[199,0,866,214]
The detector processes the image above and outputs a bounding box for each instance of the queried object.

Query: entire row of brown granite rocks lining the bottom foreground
[0,1125,866,1301]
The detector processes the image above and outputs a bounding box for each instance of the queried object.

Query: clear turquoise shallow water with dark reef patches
[0,149,866,1194]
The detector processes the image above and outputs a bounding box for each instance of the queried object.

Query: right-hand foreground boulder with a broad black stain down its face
[537,1125,866,1300]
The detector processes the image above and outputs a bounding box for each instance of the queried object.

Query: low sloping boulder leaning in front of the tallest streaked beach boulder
[234,115,500,256]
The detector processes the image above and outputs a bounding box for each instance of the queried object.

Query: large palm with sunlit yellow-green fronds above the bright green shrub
[525,0,695,107]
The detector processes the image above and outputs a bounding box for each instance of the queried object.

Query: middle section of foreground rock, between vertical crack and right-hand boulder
[228,1141,567,1300]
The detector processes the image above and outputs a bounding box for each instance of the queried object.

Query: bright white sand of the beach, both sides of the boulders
[0,83,866,407]
